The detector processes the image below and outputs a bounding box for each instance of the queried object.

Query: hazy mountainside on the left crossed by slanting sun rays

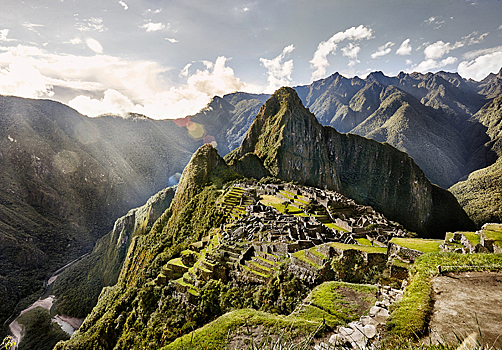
[0,96,202,321]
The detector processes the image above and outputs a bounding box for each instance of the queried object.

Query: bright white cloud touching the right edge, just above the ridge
[457,46,502,81]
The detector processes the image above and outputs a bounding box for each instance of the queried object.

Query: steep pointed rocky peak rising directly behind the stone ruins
[225,88,473,236]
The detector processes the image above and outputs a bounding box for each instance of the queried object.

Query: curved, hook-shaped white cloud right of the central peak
[310,24,373,80]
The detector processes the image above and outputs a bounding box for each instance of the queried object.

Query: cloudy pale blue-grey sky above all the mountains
[0,0,502,119]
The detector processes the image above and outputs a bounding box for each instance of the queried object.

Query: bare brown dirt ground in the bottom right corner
[424,271,502,348]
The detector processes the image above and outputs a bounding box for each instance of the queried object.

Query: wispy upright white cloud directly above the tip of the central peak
[260,45,295,93]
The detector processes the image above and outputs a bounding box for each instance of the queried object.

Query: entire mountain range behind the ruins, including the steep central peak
[0,69,502,348]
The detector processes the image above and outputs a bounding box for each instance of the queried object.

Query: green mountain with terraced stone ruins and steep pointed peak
[55,88,472,350]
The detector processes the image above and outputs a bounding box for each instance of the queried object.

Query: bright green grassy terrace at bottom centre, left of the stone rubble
[162,282,376,350]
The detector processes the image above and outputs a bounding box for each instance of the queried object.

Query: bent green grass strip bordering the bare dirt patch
[387,252,502,338]
